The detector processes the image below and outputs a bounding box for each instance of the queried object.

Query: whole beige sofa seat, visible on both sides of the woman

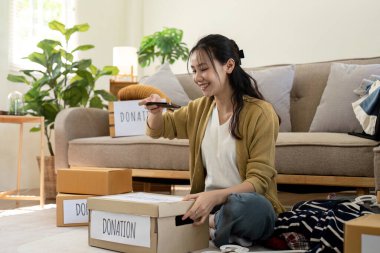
[68,133,379,177]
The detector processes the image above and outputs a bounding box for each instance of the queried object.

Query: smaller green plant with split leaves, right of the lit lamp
[137,27,189,67]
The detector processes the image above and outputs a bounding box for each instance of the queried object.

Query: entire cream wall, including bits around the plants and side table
[0,0,380,191]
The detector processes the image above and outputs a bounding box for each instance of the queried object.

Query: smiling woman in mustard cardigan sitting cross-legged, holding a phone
[144,35,283,246]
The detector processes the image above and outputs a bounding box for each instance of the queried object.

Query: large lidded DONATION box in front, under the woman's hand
[88,192,209,253]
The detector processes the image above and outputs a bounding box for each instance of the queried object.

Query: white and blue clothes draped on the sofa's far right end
[352,75,380,135]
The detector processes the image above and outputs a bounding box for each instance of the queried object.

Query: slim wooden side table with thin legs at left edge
[0,115,45,207]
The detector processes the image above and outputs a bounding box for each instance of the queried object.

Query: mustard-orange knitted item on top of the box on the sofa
[117,84,171,103]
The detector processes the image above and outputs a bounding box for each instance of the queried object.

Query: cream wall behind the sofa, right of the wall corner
[143,0,380,73]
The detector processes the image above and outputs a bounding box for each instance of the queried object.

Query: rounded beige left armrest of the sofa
[54,107,109,169]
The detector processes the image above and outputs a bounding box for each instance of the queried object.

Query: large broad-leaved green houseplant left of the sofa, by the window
[7,21,118,156]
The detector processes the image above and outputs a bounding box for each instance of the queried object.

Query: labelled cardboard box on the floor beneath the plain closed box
[56,193,94,227]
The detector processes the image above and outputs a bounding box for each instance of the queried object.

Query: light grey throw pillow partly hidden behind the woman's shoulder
[248,65,294,132]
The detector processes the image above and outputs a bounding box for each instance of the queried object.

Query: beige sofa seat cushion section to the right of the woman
[276,133,379,177]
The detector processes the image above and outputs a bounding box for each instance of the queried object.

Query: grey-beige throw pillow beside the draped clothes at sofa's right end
[309,63,380,133]
